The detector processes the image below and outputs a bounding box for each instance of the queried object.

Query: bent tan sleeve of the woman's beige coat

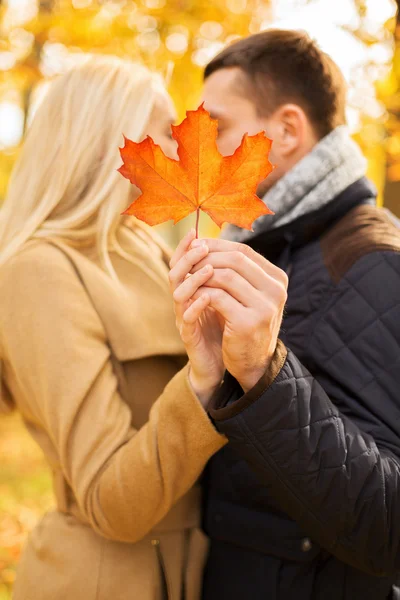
[0,247,226,542]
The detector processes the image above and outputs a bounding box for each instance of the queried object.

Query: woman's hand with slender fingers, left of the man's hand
[169,229,225,406]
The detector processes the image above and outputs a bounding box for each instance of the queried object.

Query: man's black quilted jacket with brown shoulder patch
[203,179,400,600]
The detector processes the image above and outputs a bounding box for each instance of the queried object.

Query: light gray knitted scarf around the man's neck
[222,126,366,242]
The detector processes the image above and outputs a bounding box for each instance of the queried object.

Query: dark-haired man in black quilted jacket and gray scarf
[171,30,400,600]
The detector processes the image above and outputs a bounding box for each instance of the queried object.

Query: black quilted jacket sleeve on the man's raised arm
[210,252,400,576]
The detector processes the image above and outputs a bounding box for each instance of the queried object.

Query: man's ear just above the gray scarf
[272,104,315,158]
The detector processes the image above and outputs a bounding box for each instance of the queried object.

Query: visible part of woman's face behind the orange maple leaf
[145,94,178,159]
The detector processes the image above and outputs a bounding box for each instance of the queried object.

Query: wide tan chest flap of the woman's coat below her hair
[48,239,185,362]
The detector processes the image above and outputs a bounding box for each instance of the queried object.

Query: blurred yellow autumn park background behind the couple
[0,0,400,600]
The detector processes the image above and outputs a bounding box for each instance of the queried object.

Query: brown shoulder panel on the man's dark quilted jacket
[321,205,400,283]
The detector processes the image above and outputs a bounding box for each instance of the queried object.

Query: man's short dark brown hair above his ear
[204,29,346,138]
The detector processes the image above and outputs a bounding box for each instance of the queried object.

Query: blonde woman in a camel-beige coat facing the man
[0,57,225,600]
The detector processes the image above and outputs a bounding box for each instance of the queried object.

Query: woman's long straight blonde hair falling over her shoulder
[0,56,170,274]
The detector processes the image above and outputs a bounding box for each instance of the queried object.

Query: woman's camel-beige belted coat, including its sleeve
[0,232,225,600]
